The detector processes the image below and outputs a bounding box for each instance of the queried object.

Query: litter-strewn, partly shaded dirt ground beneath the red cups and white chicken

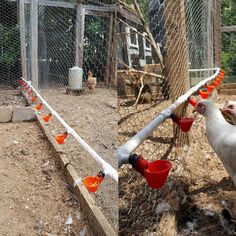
[118,96,236,236]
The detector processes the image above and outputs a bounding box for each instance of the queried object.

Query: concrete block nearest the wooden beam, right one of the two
[12,107,36,122]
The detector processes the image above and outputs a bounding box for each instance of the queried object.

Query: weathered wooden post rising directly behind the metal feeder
[75,0,85,68]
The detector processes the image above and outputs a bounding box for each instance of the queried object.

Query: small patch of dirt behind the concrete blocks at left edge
[0,89,27,106]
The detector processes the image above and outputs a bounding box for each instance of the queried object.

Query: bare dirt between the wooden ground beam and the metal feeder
[38,88,118,230]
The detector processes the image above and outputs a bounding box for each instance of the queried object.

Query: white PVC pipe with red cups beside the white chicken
[116,68,220,168]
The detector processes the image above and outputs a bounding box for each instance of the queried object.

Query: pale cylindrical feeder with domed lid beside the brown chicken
[69,66,83,90]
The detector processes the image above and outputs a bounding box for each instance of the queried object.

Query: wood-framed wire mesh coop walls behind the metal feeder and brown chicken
[0,0,115,92]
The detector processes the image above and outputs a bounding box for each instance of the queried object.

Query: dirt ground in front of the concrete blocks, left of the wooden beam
[0,123,90,236]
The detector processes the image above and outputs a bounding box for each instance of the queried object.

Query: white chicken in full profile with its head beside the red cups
[195,100,236,186]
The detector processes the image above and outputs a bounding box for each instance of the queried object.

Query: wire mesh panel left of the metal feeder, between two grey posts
[38,1,76,89]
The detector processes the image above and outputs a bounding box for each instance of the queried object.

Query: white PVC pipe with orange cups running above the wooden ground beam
[21,78,118,182]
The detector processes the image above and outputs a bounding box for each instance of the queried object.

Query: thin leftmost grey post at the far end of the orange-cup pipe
[19,0,28,80]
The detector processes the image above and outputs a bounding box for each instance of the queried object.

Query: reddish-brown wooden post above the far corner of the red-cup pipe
[213,0,221,68]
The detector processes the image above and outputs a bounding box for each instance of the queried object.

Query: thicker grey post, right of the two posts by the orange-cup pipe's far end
[30,0,38,89]
